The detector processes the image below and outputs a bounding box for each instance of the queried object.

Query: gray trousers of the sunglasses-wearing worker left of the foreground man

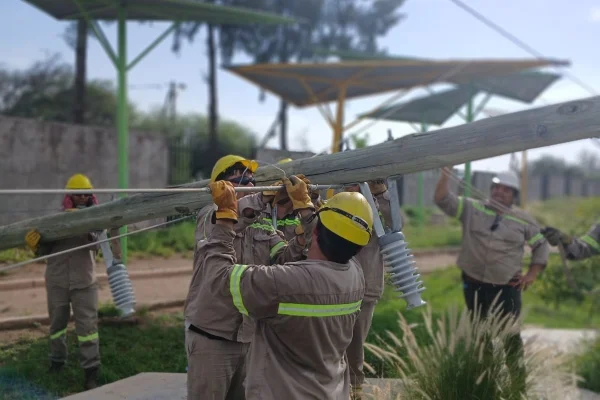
[185,329,250,400]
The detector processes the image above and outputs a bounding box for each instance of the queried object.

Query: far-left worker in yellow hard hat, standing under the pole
[25,174,116,390]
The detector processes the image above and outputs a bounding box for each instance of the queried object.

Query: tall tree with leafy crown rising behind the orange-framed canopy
[219,0,404,150]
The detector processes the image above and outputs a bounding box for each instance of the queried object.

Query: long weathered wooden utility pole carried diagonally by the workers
[0,96,600,250]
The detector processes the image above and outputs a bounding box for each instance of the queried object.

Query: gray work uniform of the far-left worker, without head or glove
[38,227,100,368]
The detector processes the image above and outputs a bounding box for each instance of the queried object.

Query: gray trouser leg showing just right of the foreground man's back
[346,300,377,387]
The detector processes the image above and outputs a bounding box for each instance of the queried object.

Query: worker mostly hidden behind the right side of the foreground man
[342,180,404,400]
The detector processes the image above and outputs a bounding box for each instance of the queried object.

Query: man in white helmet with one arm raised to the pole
[434,168,549,388]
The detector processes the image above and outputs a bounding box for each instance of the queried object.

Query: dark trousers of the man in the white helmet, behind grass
[463,274,526,390]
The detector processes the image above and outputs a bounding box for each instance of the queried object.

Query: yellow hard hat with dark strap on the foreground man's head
[319,192,373,246]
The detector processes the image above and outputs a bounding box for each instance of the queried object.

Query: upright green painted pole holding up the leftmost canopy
[117,4,129,265]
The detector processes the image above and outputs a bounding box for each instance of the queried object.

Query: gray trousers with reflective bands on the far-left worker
[46,283,100,368]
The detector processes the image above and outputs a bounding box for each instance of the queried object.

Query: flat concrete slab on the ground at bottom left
[63,372,187,400]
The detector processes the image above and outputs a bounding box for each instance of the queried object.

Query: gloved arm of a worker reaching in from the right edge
[542,221,600,260]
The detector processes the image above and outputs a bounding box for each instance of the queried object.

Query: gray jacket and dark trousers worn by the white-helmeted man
[436,193,550,390]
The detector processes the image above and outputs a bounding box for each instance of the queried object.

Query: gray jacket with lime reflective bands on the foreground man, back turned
[198,225,364,400]
